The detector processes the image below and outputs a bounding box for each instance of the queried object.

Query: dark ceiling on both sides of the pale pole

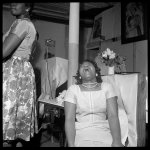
[3,2,119,27]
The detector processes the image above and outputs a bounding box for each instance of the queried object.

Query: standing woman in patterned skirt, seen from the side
[3,3,38,147]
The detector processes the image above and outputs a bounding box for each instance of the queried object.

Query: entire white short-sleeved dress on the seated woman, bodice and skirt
[64,82,117,145]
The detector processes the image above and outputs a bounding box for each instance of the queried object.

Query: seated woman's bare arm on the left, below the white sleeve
[64,102,76,147]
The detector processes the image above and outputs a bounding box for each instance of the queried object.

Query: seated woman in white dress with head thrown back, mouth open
[64,60,124,147]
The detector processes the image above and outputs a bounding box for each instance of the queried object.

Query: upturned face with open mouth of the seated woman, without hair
[79,62,96,81]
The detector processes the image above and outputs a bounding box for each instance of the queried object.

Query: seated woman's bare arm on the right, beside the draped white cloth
[106,96,124,147]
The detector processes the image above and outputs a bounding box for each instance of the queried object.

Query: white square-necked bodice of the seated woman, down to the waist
[64,82,116,123]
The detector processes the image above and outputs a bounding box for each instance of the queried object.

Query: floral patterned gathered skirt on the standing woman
[3,56,38,141]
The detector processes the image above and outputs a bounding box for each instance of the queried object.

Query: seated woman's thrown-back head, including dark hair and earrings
[75,59,102,84]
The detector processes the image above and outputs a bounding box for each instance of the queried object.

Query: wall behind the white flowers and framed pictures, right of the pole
[86,5,148,74]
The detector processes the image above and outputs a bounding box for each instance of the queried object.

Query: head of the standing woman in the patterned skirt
[10,3,33,18]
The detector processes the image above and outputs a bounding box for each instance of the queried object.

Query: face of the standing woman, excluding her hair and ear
[10,3,26,16]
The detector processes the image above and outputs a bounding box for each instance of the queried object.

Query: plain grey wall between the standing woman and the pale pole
[34,20,67,66]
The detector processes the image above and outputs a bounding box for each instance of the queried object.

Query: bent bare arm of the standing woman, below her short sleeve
[3,33,22,58]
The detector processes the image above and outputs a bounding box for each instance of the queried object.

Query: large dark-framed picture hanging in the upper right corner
[121,2,148,44]
